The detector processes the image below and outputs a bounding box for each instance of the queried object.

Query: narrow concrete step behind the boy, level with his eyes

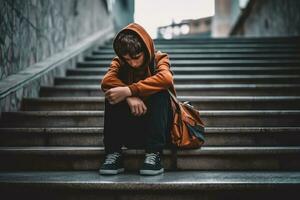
[84,53,300,61]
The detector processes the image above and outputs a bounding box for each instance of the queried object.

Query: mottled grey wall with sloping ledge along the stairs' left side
[0,0,133,117]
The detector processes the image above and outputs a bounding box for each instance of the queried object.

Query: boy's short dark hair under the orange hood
[114,31,145,57]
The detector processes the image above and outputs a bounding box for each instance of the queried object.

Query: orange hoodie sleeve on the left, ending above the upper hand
[101,57,126,92]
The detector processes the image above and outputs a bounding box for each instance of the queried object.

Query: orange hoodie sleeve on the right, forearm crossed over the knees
[128,52,173,97]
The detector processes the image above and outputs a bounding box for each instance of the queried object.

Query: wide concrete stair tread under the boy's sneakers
[0,170,300,191]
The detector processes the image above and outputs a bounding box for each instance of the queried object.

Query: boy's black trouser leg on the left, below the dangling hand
[103,100,146,153]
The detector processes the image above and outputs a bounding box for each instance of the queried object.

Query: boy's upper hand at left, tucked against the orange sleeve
[105,87,132,104]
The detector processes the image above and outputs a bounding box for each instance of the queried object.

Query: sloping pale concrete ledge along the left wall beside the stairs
[0,27,113,115]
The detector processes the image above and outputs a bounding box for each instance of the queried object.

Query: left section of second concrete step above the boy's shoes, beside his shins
[0,127,104,147]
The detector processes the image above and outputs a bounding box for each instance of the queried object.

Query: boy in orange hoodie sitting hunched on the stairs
[99,23,175,175]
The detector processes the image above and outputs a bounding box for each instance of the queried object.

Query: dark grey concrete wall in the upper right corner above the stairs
[239,0,300,36]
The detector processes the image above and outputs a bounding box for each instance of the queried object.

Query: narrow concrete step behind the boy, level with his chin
[77,59,300,68]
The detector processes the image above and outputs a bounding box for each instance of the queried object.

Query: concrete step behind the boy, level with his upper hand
[40,84,300,97]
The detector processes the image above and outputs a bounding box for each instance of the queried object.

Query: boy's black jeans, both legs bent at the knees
[103,90,172,153]
